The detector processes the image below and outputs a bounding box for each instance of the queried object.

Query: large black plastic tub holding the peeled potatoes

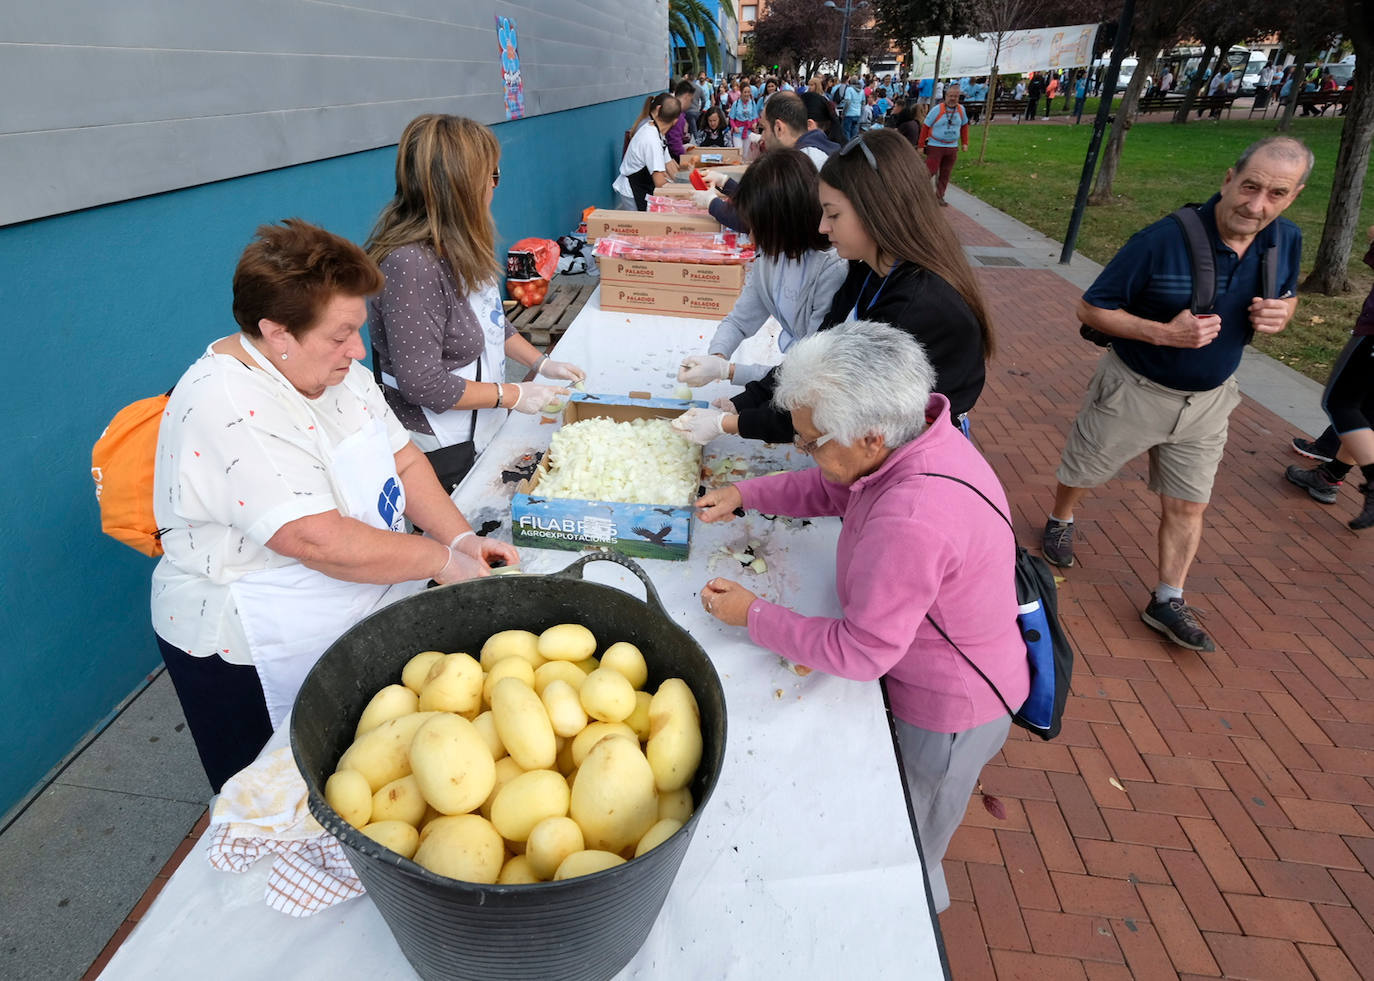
[291,552,725,981]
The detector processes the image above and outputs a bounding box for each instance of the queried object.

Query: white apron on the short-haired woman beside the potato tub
[229,336,425,728]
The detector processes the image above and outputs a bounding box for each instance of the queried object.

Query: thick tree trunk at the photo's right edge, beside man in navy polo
[1303,41,1374,295]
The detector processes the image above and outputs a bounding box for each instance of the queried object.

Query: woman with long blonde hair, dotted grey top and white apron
[367,114,585,491]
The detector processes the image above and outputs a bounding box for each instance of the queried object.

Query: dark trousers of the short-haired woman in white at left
[158,638,272,793]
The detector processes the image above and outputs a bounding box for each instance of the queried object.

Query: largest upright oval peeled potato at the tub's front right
[569,738,658,852]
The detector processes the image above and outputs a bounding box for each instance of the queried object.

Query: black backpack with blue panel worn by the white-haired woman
[921,474,1073,739]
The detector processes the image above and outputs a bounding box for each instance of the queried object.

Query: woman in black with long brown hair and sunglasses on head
[673,129,993,442]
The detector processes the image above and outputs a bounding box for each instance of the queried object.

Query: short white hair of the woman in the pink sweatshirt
[774,320,936,449]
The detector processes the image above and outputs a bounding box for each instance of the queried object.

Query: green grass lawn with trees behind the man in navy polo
[954,110,1374,382]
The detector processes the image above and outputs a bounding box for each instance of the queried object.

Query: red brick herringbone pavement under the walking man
[940,201,1374,981]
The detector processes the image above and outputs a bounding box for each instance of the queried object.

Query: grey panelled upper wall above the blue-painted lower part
[0,0,668,224]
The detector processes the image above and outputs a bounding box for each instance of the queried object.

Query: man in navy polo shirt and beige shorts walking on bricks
[1043,136,1312,651]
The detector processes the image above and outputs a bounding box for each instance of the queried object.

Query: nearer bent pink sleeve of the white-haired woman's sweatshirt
[749,518,958,681]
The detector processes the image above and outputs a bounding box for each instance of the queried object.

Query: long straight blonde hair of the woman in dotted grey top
[367,113,502,290]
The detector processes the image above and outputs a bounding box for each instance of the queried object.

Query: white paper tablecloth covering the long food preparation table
[102,287,944,981]
